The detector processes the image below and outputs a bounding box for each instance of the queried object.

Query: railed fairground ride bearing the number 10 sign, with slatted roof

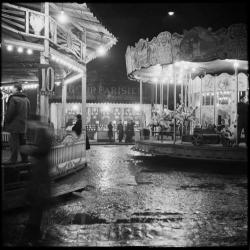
[1,2,117,209]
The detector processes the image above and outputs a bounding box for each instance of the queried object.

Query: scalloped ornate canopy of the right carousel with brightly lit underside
[125,24,248,83]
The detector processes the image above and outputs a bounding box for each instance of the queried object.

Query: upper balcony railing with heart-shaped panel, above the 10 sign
[1,3,86,61]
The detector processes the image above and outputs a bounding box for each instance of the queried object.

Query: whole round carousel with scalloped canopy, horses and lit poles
[125,23,249,162]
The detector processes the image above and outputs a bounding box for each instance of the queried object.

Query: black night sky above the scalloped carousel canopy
[87,1,247,81]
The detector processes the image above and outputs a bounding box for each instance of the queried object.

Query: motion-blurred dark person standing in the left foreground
[21,115,52,246]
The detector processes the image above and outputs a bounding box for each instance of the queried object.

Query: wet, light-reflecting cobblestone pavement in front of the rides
[4,146,248,247]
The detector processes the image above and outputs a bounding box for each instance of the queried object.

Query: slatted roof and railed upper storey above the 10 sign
[1,2,117,84]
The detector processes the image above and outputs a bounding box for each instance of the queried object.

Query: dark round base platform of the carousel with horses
[133,138,248,163]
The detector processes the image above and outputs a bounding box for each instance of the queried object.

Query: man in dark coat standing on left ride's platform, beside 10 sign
[5,83,30,164]
